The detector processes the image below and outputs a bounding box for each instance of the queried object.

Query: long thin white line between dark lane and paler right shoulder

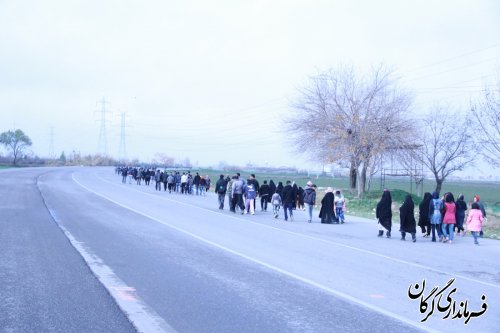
[71,173,439,332]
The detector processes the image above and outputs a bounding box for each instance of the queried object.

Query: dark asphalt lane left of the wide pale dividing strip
[0,169,135,332]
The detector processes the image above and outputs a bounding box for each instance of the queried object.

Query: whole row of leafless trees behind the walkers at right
[285,66,500,197]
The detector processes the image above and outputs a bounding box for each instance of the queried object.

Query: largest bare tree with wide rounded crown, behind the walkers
[286,66,413,196]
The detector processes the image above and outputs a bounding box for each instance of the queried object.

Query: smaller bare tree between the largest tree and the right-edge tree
[414,106,474,192]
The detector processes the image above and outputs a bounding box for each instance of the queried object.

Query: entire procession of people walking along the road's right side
[116,167,486,244]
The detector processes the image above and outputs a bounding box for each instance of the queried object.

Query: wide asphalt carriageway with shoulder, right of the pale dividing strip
[1,168,500,332]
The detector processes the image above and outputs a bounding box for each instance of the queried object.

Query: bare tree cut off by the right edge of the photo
[471,79,500,166]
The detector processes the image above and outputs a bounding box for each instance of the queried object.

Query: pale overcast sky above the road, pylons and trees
[0,0,500,174]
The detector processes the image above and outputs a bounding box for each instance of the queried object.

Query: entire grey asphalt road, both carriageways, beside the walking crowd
[0,168,500,332]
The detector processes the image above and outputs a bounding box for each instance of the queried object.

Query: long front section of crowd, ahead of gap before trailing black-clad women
[116,167,346,224]
